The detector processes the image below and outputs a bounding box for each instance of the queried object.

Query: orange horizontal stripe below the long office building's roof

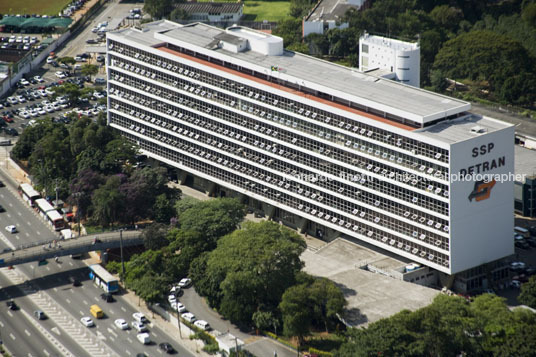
[157,46,415,131]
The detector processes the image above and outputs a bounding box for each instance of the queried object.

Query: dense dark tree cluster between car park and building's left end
[12,116,180,226]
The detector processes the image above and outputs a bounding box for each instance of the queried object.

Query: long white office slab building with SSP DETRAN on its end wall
[107,21,514,274]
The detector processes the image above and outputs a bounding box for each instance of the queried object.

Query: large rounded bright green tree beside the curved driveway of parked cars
[199,220,305,325]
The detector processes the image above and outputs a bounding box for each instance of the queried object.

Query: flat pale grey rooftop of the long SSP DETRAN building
[111,21,510,143]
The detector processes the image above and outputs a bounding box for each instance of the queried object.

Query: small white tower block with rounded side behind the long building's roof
[359,33,421,87]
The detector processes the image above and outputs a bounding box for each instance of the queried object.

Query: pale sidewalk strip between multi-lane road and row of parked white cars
[84,252,214,357]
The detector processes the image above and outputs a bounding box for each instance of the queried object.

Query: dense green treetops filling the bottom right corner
[337,294,536,357]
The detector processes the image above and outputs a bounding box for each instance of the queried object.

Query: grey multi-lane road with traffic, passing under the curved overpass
[0,172,192,356]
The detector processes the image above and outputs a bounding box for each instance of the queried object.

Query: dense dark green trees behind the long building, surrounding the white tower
[274,0,536,107]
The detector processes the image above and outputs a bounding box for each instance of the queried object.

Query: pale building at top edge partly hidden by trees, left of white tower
[302,0,365,37]
